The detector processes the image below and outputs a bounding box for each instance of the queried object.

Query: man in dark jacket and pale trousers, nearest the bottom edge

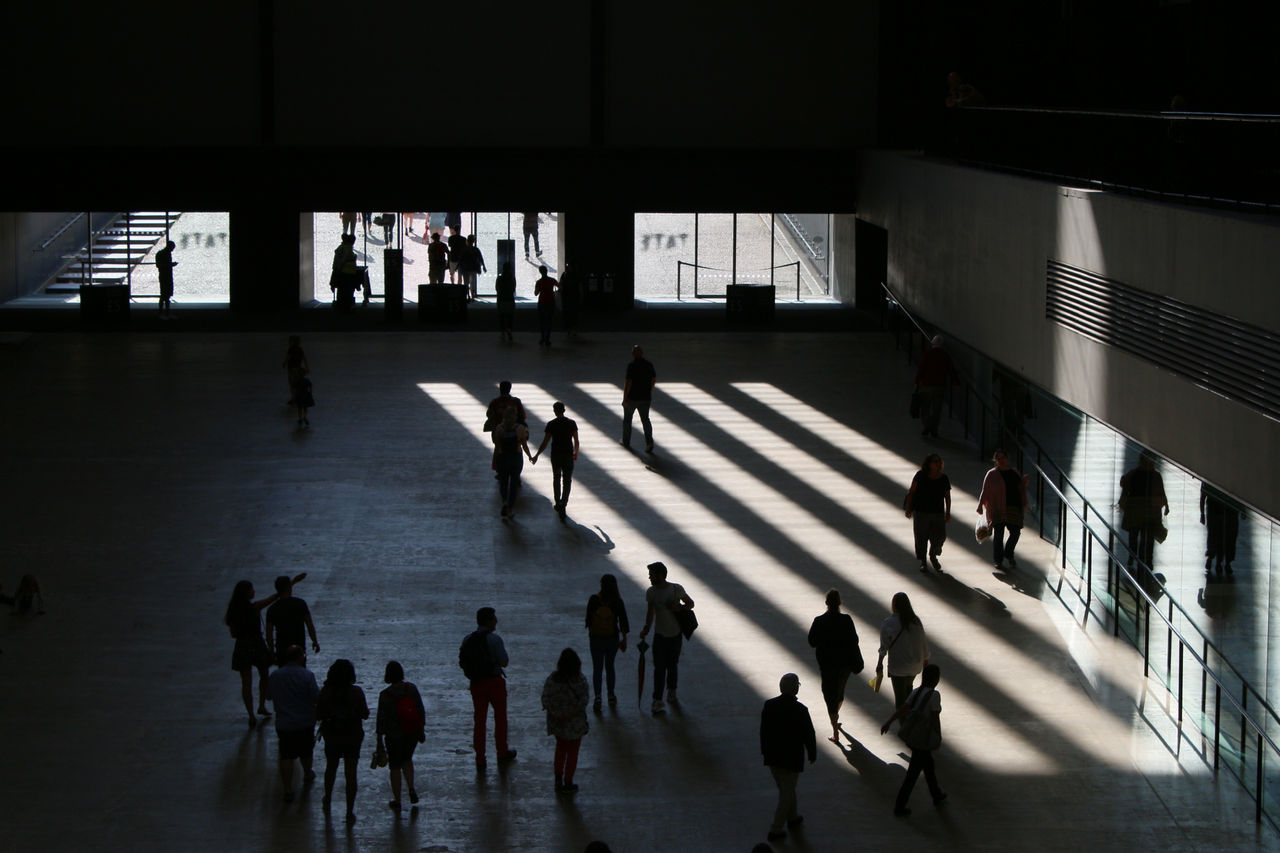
[760,672,818,841]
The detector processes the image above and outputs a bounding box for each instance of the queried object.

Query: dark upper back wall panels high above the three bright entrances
[10,0,878,149]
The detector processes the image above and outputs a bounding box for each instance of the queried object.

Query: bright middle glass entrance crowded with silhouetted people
[314,211,559,302]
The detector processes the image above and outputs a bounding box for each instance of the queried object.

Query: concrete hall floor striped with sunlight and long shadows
[0,326,1280,853]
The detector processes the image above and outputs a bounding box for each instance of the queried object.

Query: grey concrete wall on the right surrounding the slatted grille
[858,152,1280,517]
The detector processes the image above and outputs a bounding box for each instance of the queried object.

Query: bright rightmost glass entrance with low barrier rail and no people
[635,213,831,300]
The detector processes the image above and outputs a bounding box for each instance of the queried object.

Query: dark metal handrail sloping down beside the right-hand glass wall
[881,282,1280,818]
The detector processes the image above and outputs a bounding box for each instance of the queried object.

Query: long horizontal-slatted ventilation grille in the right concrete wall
[1044,260,1280,420]
